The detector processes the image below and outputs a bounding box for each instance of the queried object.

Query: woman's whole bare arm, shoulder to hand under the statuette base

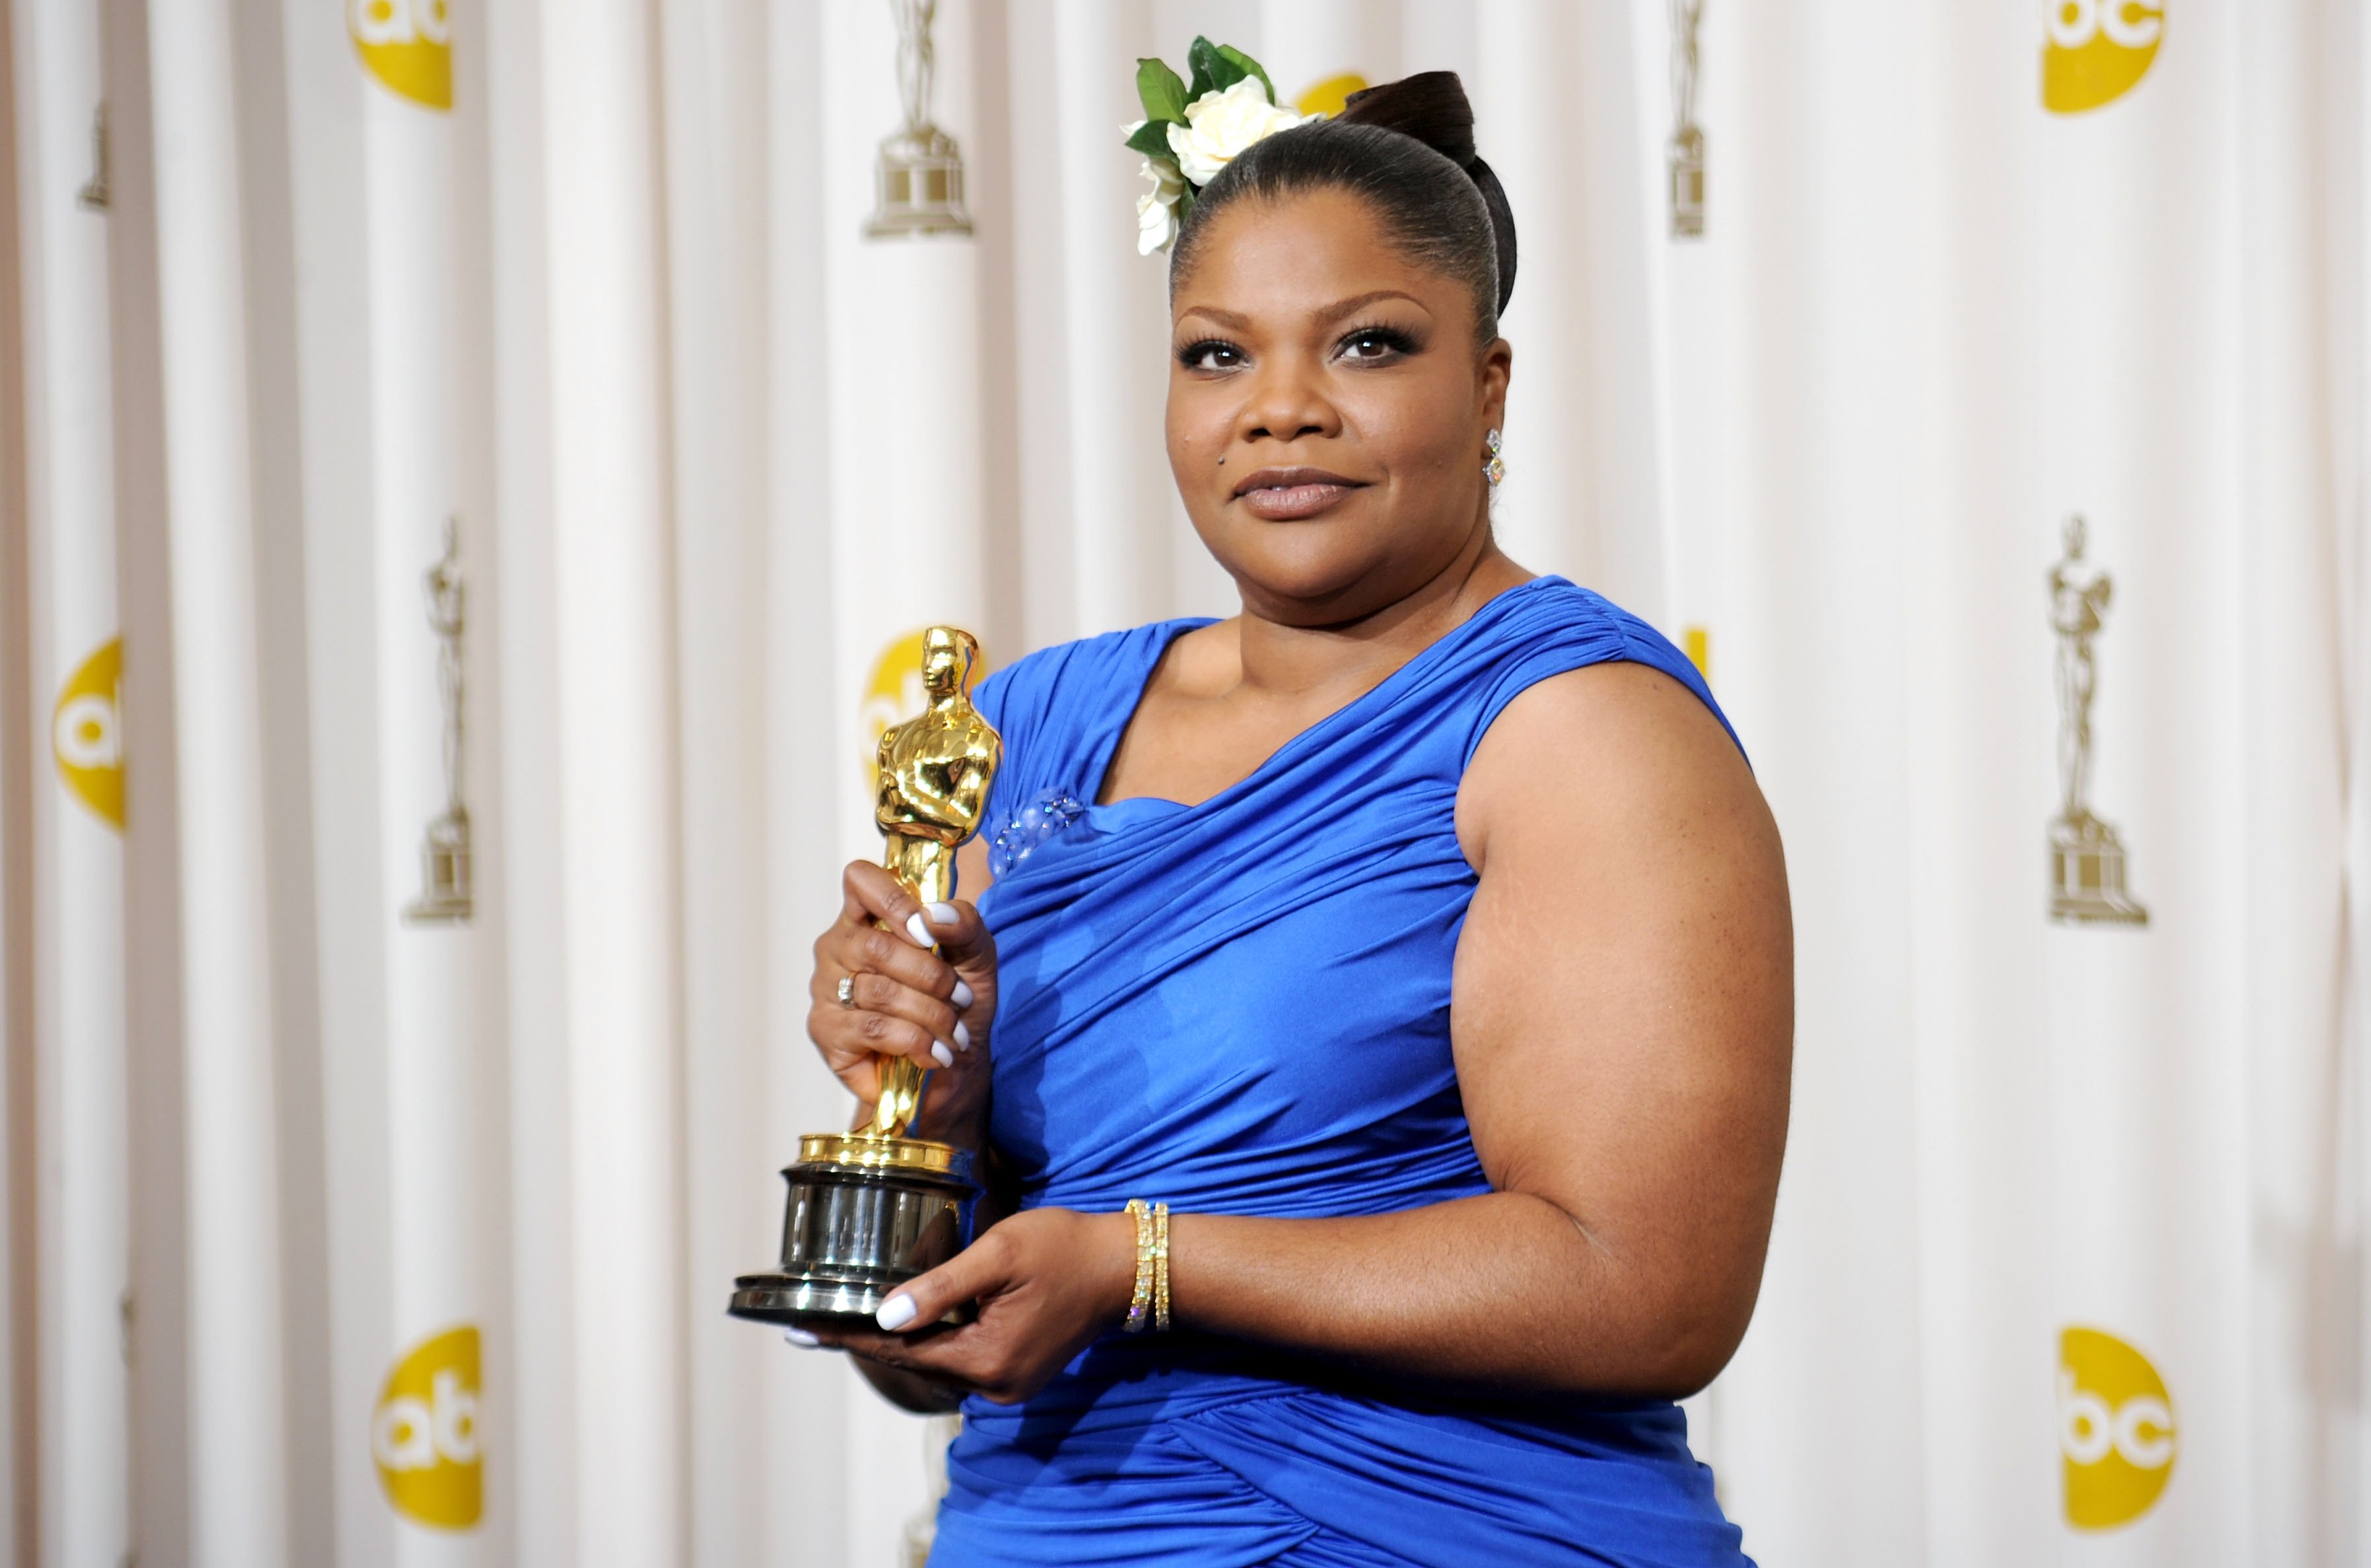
[834,664,1793,1397]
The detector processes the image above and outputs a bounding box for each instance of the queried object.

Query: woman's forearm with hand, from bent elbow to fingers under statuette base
[816,1193,1759,1402]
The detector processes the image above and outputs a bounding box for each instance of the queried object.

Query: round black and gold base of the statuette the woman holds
[728,1132,979,1324]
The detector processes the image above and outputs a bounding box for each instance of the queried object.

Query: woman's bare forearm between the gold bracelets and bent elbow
[1169,1193,1752,1397]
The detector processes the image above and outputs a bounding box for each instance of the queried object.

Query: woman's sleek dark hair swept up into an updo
[1169,71,1515,344]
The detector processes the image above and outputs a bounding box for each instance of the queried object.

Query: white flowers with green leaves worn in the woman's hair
[1124,38,1325,256]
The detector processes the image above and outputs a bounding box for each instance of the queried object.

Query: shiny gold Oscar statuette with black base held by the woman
[730,626,1003,1324]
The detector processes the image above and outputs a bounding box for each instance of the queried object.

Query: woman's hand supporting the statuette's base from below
[801,1210,1136,1404]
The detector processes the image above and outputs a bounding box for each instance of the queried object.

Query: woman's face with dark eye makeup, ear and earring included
[1169,190,1513,626]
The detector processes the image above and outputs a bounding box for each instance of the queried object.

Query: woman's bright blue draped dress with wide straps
[932,576,1745,1568]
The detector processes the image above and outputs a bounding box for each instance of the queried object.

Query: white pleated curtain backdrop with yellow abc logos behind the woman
[0,0,2371,1568]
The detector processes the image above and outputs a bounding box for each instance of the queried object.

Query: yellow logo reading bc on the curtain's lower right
[2058,1328,2174,1530]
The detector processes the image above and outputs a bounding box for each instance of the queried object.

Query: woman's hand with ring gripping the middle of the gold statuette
[806,861,996,1144]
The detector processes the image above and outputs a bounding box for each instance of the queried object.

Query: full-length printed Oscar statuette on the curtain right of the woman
[2051,517,2148,925]
